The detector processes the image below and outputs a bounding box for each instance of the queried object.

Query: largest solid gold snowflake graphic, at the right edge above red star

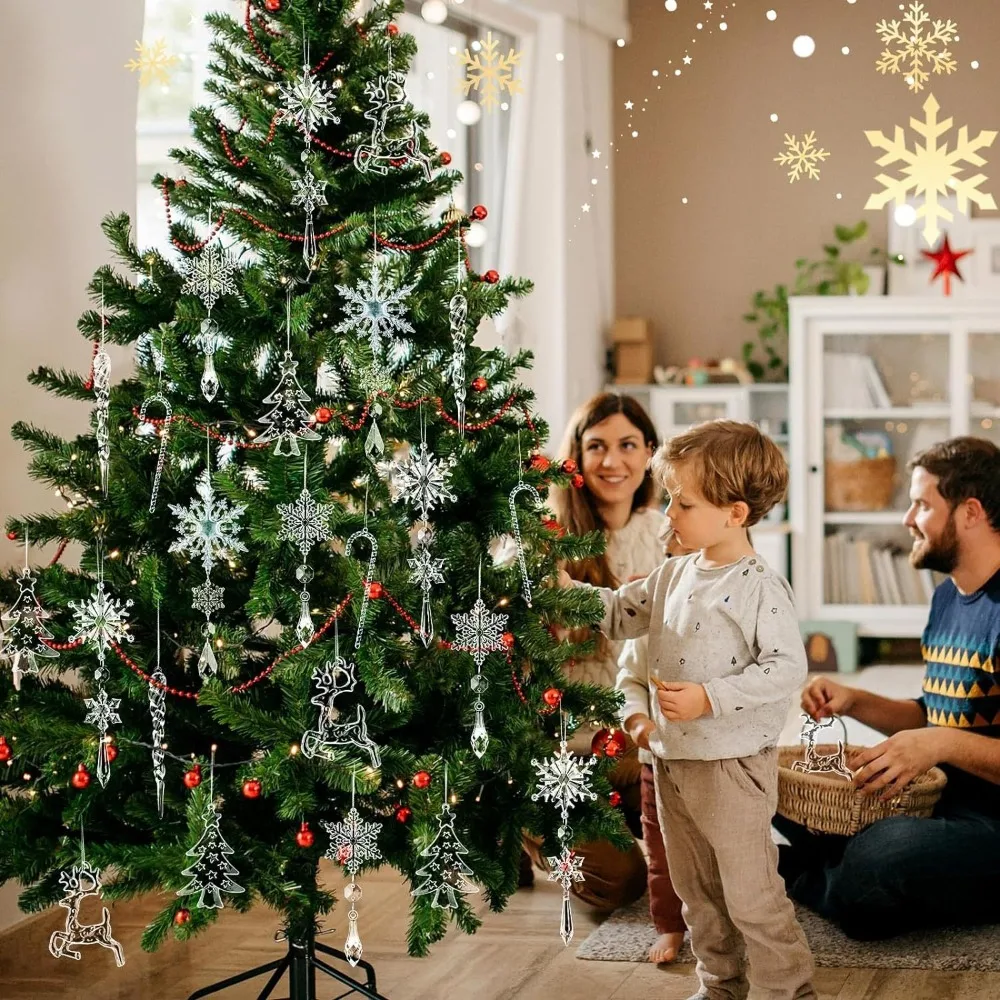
[865,94,997,246]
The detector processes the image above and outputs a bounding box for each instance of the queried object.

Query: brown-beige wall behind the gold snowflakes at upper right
[614,0,1000,363]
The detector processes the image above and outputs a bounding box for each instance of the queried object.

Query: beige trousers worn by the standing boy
[654,747,816,1000]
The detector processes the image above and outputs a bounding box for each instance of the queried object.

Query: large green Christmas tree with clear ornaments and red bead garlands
[0,0,630,968]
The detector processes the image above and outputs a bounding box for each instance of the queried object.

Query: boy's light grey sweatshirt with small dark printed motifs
[577,553,807,760]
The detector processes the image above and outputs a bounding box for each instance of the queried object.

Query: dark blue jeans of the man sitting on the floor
[774,793,1000,940]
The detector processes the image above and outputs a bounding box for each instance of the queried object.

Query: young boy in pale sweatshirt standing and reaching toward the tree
[560,420,816,1000]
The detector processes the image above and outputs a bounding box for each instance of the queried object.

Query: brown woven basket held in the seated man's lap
[778,744,948,837]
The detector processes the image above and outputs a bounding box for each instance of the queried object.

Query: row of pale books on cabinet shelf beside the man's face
[823,531,943,606]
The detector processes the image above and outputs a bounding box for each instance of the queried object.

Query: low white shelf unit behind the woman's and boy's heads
[607,382,789,577]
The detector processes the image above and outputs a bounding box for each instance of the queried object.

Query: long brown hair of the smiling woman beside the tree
[551,392,658,587]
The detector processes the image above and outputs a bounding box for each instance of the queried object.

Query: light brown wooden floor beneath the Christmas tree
[0,856,1000,1000]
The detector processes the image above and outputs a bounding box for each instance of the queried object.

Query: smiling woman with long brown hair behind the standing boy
[525,393,684,962]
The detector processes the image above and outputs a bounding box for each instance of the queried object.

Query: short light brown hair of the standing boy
[650,420,788,528]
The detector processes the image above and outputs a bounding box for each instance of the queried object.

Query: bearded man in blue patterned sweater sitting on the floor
[775,437,1000,939]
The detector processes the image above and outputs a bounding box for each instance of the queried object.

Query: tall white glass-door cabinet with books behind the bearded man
[789,296,1000,638]
